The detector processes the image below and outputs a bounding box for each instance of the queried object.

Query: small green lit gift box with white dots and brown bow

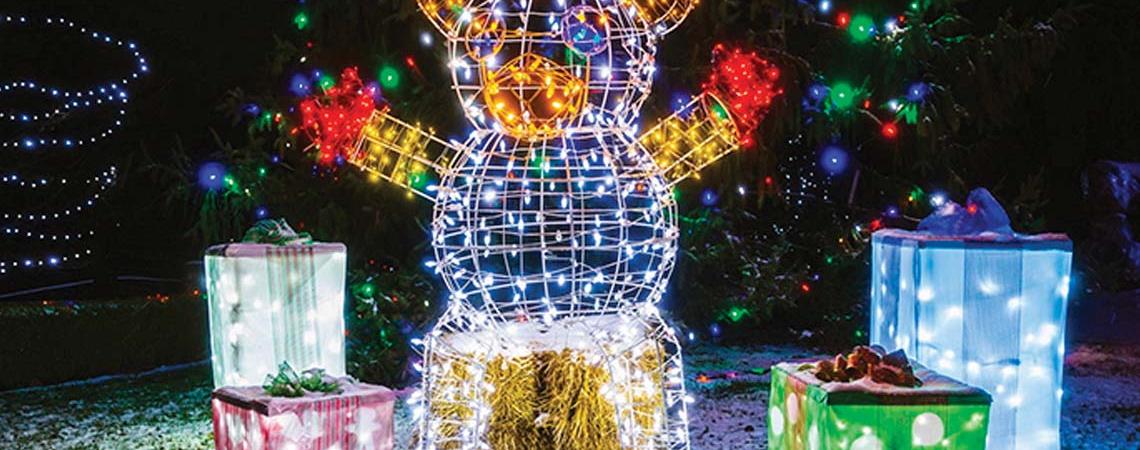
[768,362,991,450]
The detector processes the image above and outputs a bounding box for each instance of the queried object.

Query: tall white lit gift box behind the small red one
[205,243,345,386]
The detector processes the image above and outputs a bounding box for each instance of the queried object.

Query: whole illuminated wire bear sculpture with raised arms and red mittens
[301,0,780,449]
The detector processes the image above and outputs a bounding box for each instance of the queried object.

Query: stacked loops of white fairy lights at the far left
[0,15,149,275]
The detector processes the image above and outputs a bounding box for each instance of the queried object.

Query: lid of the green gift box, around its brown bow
[772,361,993,404]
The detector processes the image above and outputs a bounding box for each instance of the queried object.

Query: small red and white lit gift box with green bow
[211,378,396,450]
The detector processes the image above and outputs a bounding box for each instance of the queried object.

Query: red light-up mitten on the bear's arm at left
[300,67,376,164]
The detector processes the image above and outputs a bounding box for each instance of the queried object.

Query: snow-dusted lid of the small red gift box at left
[210,377,396,416]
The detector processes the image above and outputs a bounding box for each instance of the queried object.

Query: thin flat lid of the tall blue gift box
[871,228,1073,252]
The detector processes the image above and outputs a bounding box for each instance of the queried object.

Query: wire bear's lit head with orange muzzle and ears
[421,0,694,141]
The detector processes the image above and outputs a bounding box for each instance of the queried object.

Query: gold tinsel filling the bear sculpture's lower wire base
[430,344,665,450]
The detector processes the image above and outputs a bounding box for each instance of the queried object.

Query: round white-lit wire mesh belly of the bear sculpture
[432,133,679,322]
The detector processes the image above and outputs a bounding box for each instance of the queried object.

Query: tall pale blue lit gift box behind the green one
[871,230,1073,449]
